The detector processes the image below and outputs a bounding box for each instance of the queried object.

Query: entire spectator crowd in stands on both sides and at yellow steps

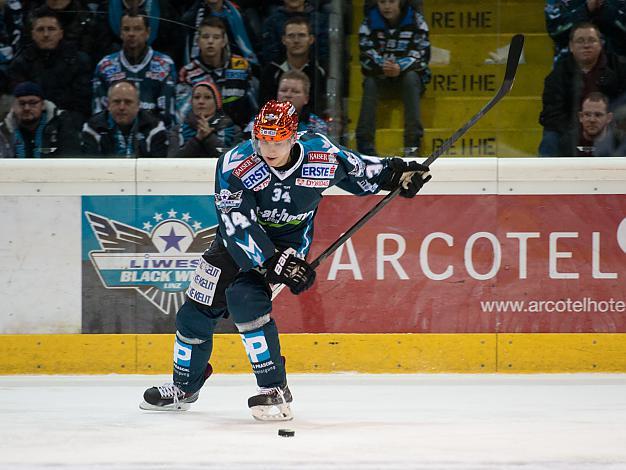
[0,0,626,158]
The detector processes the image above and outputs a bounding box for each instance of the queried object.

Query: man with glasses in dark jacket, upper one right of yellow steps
[539,23,626,157]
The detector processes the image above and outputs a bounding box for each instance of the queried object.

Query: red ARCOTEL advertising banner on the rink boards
[274,195,626,333]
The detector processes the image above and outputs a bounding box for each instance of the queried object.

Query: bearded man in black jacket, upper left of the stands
[9,7,91,118]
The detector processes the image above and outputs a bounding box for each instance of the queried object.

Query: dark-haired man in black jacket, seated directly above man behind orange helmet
[260,16,326,114]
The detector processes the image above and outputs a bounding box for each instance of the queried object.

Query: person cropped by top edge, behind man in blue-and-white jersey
[105,0,184,66]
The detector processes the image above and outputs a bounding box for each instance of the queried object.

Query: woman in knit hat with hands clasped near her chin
[170,82,242,158]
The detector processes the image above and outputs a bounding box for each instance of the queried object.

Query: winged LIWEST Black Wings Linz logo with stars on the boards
[85,209,217,315]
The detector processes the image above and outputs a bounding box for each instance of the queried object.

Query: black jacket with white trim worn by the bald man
[81,110,168,158]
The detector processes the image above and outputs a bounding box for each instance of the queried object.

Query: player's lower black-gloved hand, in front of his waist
[265,248,315,295]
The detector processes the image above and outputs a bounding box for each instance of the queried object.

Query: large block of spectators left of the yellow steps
[0,0,329,158]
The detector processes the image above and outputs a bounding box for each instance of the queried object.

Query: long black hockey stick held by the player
[272,34,524,299]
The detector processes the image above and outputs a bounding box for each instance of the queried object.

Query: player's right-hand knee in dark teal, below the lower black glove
[226,273,272,332]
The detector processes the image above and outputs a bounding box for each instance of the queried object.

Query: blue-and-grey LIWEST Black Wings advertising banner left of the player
[82,196,227,333]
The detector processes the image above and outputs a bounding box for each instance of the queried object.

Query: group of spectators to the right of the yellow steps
[539,0,626,157]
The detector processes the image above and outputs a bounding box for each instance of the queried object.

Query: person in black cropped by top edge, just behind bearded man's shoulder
[28,0,112,69]
